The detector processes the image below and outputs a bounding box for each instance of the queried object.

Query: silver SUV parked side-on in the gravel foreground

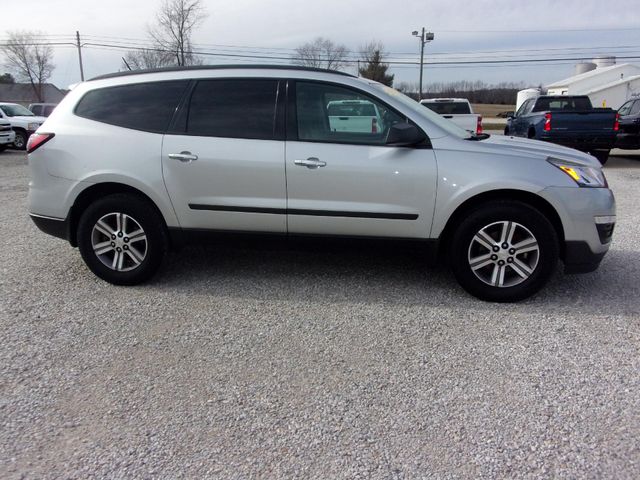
[28,66,615,301]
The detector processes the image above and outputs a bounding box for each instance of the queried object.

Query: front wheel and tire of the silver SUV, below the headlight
[449,200,559,302]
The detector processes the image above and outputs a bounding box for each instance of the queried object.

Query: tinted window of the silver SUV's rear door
[187,79,278,140]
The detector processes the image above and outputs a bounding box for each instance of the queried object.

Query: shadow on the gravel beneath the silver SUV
[145,240,640,315]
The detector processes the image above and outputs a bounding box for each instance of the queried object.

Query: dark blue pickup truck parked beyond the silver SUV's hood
[504,95,618,164]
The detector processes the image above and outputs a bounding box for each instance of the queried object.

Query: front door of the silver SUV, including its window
[286,80,437,238]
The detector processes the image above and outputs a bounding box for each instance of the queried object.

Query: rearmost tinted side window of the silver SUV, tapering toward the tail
[75,80,188,133]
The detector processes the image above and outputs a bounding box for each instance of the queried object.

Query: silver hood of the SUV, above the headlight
[482,135,602,168]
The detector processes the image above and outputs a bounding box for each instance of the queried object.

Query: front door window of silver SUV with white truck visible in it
[296,82,407,145]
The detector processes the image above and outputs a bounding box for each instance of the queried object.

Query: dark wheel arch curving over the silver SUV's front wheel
[438,189,565,258]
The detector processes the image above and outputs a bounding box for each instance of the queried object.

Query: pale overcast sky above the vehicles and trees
[5,0,640,87]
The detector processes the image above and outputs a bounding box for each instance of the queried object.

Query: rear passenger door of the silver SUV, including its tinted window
[162,78,286,233]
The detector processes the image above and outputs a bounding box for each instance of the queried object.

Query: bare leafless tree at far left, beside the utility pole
[2,32,55,102]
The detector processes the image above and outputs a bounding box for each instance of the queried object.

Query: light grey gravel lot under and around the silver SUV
[0,152,640,479]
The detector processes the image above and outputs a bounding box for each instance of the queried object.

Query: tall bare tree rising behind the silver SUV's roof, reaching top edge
[149,0,206,66]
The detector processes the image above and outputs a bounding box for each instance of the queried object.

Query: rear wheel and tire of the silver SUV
[77,194,169,285]
